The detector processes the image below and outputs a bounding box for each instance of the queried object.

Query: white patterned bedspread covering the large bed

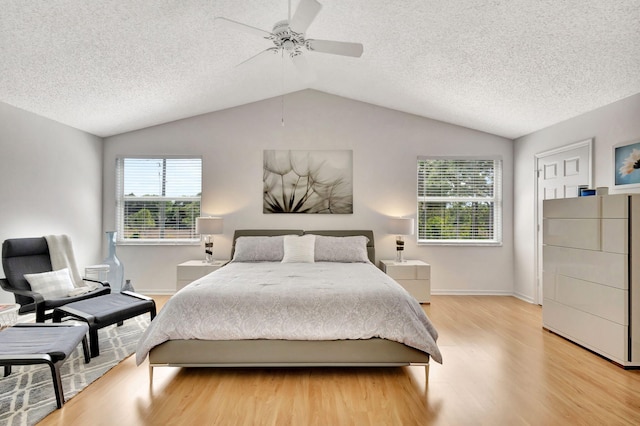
[136,262,442,365]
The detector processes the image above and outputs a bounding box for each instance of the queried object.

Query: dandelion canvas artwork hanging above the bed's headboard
[263,150,353,214]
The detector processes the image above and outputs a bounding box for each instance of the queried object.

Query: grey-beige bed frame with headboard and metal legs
[149,229,430,383]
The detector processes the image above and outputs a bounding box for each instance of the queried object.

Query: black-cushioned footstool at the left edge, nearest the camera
[0,323,91,408]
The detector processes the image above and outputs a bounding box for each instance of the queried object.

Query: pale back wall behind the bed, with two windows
[103,90,513,294]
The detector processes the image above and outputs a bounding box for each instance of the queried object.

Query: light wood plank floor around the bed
[40,296,640,426]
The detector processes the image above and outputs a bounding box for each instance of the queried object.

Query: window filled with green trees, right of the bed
[418,157,502,245]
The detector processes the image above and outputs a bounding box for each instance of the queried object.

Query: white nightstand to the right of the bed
[380,260,431,303]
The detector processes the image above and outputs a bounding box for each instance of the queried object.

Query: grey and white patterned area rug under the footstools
[0,315,149,426]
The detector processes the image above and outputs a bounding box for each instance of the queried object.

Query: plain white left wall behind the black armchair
[0,103,102,303]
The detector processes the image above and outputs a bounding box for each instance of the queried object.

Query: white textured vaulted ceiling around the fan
[0,0,640,138]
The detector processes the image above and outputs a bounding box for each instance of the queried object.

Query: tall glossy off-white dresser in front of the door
[542,194,640,367]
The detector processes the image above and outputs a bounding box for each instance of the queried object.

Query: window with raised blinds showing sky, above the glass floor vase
[116,157,202,243]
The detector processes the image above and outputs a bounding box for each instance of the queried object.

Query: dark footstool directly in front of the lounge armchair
[53,291,156,358]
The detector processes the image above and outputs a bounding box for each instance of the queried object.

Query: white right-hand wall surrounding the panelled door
[514,94,640,301]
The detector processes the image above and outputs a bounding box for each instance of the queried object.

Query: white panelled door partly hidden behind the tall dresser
[535,139,593,305]
